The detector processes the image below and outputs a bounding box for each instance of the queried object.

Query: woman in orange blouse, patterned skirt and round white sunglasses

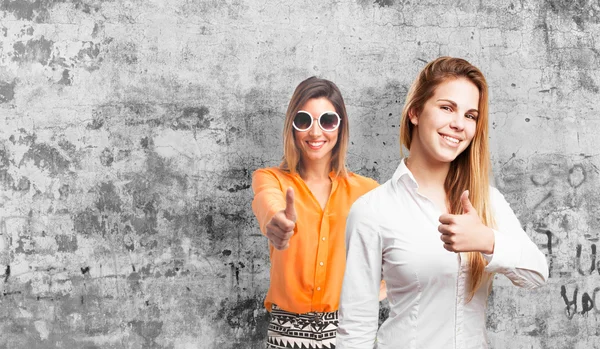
[252,77,377,348]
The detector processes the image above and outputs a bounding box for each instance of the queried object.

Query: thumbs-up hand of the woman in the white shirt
[438,190,494,254]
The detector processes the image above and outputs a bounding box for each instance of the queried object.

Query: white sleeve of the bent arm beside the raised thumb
[484,188,548,289]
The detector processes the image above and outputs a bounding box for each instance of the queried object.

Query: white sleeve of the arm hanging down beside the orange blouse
[336,199,382,349]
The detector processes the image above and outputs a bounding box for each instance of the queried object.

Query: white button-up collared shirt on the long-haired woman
[337,160,548,349]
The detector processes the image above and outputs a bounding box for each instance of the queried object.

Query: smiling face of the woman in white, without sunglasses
[409,78,479,163]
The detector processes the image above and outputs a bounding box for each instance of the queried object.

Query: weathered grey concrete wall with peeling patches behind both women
[0,0,600,349]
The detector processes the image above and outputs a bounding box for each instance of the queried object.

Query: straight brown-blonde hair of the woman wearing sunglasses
[279,76,350,177]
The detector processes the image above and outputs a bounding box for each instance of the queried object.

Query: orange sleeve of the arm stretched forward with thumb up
[252,169,285,234]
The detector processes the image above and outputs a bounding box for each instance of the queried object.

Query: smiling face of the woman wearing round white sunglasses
[294,98,343,166]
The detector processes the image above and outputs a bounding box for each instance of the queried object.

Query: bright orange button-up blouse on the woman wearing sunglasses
[252,167,378,313]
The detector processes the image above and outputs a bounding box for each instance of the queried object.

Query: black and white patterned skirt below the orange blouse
[267,304,338,349]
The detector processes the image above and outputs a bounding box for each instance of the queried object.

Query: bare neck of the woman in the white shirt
[406,151,450,188]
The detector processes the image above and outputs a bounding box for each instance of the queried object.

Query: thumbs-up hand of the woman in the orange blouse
[266,188,296,250]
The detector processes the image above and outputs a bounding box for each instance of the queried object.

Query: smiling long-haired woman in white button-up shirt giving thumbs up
[338,57,548,349]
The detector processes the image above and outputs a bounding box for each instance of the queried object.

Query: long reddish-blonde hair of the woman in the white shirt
[400,57,495,301]
